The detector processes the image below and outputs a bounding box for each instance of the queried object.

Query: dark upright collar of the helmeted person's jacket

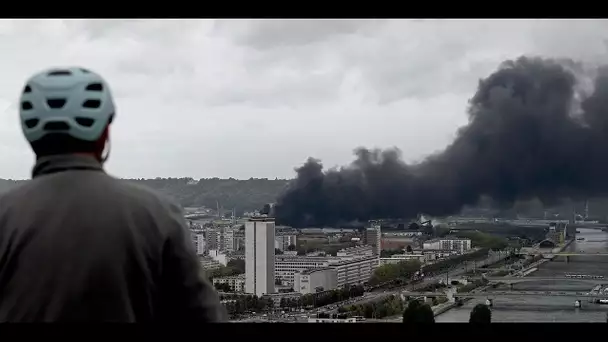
[32,154,104,178]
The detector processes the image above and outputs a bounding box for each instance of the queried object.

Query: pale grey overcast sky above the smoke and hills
[0,20,608,179]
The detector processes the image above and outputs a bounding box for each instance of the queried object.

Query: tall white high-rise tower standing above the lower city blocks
[245,217,275,297]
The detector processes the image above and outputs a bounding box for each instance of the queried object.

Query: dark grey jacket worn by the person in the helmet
[0,155,226,322]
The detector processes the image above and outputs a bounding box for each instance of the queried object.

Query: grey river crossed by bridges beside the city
[436,228,608,323]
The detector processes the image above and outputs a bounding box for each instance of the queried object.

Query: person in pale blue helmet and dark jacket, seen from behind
[0,68,226,322]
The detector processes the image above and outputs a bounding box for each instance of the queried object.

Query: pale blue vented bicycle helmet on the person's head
[19,67,115,142]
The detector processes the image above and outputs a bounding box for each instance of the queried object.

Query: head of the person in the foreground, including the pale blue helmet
[19,67,115,161]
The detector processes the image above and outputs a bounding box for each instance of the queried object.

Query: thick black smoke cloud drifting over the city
[275,57,608,227]
